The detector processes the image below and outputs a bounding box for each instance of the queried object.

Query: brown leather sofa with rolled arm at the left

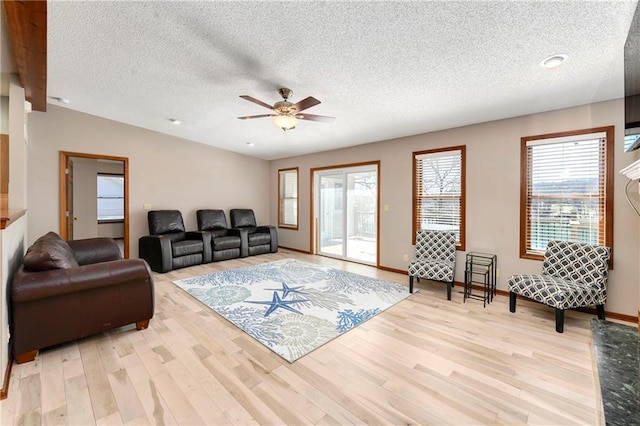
[10,232,154,363]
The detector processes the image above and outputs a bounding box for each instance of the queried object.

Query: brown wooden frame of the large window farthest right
[520,126,615,262]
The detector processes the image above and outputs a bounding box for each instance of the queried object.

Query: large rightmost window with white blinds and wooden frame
[520,127,613,259]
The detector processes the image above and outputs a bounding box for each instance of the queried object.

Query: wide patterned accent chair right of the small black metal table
[508,241,611,333]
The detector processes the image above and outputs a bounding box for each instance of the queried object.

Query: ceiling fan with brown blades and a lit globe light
[238,88,336,131]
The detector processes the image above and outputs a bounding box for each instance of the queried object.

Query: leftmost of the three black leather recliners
[138,210,211,273]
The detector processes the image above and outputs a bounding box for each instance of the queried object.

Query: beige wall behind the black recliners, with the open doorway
[28,105,270,257]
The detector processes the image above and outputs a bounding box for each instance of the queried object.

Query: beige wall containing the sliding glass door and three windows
[270,100,640,316]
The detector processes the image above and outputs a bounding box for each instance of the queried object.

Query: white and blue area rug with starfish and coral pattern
[174,259,409,362]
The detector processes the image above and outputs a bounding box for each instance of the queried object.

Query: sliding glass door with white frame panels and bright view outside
[314,164,378,265]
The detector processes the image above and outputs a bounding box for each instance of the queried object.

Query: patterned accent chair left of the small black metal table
[408,230,456,300]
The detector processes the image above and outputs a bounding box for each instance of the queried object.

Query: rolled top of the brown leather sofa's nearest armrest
[11,259,153,303]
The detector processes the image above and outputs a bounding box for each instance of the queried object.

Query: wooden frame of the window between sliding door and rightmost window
[411,145,467,251]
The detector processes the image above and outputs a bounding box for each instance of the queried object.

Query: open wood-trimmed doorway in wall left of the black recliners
[59,151,129,258]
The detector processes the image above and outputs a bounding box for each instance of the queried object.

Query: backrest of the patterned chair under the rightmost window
[542,241,611,287]
